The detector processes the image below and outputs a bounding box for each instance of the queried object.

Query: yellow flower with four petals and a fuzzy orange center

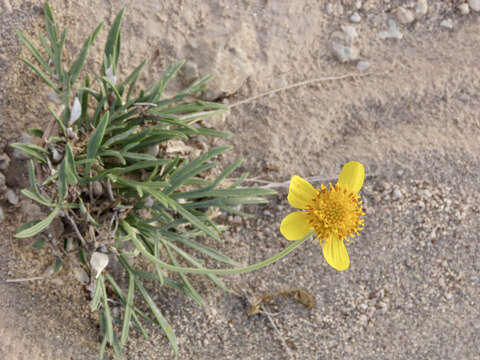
[280,161,365,271]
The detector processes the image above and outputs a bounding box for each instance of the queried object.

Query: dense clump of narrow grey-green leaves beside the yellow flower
[12,4,273,358]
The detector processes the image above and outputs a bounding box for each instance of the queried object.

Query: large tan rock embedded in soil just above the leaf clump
[182,23,258,100]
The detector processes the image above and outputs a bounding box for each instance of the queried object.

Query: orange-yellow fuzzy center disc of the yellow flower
[307,183,365,241]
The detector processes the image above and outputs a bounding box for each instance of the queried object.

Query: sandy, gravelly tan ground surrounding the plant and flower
[0,0,480,360]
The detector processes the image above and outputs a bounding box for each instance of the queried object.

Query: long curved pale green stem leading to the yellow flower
[121,221,310,275]
